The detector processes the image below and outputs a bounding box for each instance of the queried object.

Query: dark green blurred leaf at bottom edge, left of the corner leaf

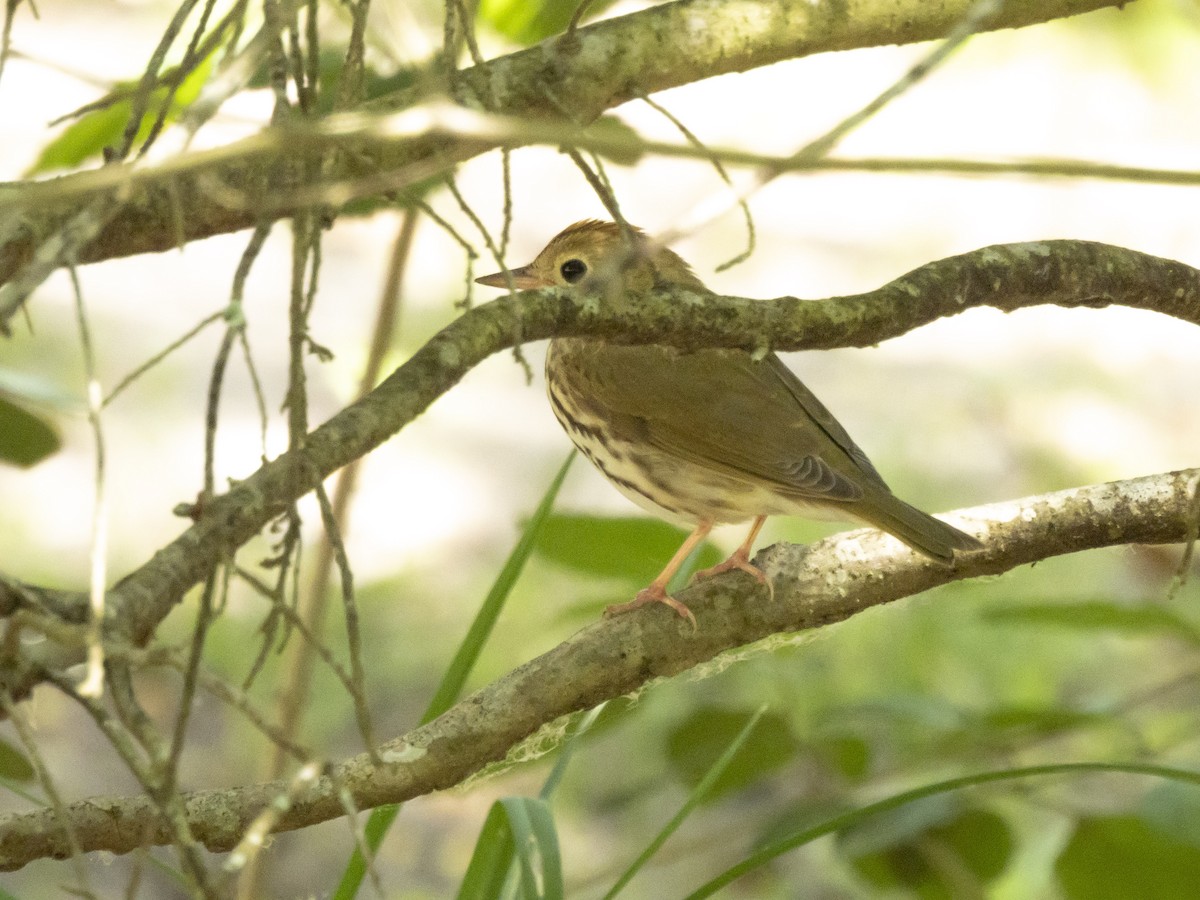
[853,809,1014,900]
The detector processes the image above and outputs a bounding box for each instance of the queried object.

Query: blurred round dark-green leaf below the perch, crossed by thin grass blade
[667,707,800,800]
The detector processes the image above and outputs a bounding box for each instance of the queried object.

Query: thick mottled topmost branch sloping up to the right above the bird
[0,0,1127,284]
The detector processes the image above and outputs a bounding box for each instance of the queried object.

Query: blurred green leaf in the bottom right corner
[1055,816,1200,900]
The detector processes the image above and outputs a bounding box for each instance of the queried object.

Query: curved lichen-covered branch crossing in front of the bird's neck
[0,241,1200,697]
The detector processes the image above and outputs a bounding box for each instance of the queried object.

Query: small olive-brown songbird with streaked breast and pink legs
[478,221,982,625]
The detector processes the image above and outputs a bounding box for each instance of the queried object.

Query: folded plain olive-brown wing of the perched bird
[572,344,883,502]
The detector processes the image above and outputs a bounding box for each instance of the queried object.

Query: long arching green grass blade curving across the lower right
[685,762,1200,900]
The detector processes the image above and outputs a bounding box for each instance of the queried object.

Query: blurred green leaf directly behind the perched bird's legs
[535,515,722,584]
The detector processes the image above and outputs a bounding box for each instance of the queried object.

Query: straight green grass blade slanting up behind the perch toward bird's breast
[334,450,575,900]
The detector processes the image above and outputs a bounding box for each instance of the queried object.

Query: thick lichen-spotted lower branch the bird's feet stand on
[0,469,1200,870]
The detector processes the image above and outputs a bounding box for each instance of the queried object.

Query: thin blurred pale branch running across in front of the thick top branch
[9,101,1200,250]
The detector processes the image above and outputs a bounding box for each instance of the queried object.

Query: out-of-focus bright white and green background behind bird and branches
[0,0,1200,898]
